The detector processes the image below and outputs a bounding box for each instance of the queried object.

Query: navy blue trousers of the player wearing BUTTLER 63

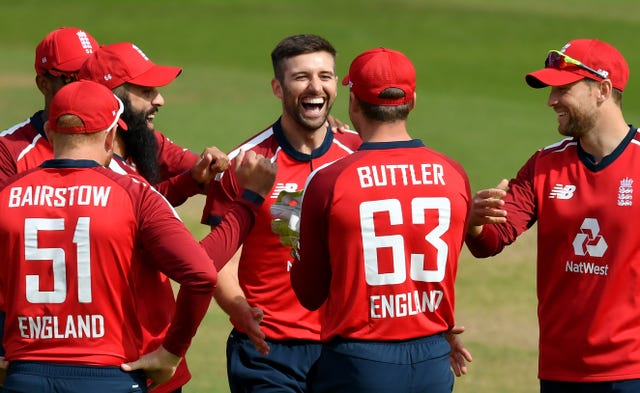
[308,334,454,393]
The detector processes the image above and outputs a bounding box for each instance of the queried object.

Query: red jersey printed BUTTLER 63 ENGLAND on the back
[291,140,471,342]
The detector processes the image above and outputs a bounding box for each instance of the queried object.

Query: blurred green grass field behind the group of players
[0,0,640,393]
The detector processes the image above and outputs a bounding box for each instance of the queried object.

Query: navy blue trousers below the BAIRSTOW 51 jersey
[2,361,147,393]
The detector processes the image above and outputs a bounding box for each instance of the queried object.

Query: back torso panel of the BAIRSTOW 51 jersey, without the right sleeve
[0,160,149,365]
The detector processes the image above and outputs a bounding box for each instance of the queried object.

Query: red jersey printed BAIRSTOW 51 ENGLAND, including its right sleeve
[0,160,216,366]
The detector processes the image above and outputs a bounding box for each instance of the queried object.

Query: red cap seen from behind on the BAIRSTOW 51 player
[48,80,126,134]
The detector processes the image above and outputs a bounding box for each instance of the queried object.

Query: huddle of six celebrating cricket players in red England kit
[0,23,640,393]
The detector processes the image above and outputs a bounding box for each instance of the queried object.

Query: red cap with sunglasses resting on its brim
[525,38,629,91]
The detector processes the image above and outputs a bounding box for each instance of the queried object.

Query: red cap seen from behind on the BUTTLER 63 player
[342,48,416,106]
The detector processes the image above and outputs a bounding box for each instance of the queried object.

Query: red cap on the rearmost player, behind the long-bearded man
[35,27,99,76]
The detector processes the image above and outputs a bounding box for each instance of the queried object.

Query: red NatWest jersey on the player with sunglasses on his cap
[467,128,640,382]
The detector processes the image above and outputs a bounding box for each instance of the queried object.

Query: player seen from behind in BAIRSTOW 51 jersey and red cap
[0,81,218,393]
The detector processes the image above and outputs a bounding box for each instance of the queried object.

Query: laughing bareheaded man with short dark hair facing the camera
[202,35,362,393]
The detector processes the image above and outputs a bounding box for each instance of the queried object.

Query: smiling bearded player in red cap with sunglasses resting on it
[466,38,640,393]
